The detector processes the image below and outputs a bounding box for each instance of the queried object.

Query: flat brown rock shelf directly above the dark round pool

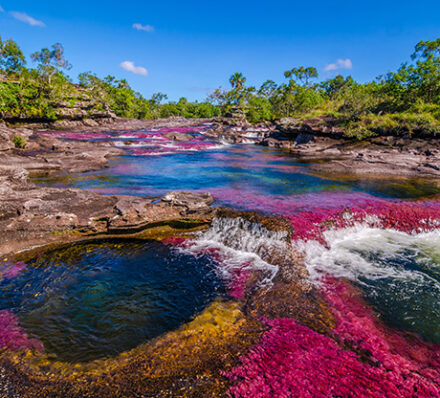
[0,156,214,255]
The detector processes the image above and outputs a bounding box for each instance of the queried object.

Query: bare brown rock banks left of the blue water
[0,116,220,255]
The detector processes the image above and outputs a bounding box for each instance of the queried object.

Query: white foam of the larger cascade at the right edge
[294,224,440,282]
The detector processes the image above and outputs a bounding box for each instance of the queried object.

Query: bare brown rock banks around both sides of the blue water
[0,113,440,268]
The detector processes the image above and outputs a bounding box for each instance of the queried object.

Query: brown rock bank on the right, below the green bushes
[205,118,440,178]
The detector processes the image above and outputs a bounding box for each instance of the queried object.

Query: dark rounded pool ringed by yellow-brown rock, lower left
[0,241,223,362]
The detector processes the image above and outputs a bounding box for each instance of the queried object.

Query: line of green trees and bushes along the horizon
[0,34,440,138]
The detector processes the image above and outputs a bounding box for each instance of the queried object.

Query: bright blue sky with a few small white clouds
[0,0,440,100]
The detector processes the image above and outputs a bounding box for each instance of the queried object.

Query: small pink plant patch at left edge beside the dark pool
[0,310,43,351]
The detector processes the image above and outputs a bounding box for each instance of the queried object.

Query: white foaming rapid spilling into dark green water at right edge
[294,224,440,344]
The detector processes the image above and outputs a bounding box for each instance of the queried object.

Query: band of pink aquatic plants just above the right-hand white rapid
[203,187,440,241]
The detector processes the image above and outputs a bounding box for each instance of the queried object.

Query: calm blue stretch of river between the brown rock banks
[34,145,440,204]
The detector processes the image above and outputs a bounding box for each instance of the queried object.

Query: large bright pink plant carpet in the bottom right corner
[223,280,440,398]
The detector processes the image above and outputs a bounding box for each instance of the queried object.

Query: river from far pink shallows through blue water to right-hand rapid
[0,127,440,359]
